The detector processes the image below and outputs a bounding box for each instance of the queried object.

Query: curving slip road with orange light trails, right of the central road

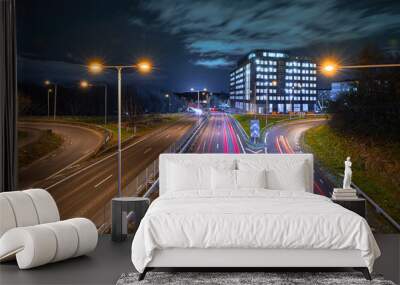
[267,120,334,197]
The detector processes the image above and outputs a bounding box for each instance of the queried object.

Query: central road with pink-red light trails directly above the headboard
[189,112,243,153]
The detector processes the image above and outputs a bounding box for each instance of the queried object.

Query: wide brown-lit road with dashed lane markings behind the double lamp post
[35,116,196,226]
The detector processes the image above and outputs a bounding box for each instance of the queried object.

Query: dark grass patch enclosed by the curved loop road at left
[18,130,63,167]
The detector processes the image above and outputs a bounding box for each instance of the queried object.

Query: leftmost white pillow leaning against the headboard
[168,163,211,191]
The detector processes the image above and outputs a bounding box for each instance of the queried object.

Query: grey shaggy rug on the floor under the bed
[117,272,395,285]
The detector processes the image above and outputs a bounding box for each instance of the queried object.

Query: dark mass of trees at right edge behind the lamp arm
[328,47,400,141]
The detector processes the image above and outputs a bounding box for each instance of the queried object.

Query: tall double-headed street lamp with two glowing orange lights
[88,61,152,197]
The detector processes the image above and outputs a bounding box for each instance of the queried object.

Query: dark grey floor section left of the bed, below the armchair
[0,235,135,285]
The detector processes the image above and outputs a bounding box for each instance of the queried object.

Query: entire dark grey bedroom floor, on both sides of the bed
[0,234,400,285]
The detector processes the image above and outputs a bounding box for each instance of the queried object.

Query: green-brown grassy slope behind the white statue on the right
[304,125,400,231]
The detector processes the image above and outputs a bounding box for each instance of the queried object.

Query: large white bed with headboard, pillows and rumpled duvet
[132,154,380,279]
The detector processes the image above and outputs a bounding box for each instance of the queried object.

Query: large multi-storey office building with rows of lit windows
[229,50,317,113]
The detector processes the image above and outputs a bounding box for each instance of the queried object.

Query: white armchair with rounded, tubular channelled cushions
[0,189,98,269]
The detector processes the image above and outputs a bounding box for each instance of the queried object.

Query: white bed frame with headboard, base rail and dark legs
[139,154,371,280]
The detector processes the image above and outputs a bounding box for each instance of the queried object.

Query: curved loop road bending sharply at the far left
[18,122,104,189]
